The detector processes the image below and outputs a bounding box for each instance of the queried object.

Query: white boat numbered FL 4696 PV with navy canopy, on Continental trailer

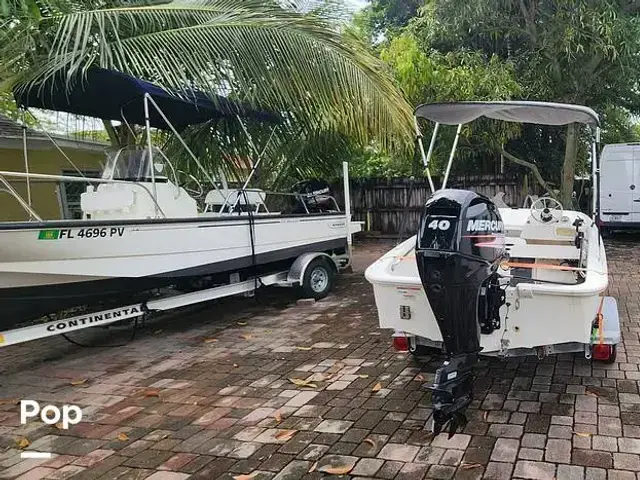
[0,68,360,347]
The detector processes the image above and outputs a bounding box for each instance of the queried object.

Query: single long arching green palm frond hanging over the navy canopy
[8,0,412,147]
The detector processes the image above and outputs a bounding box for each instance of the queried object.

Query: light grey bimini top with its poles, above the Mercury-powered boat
[414,101,600,218]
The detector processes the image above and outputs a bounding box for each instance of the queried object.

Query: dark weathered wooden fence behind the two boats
[334,175,539,237]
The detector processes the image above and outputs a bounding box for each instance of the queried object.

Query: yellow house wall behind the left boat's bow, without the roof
[0,147,105,221]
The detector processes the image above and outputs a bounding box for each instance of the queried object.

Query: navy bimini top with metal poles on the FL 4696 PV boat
[3,67,282,219]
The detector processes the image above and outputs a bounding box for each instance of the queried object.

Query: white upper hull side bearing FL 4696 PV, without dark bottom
[0,215,346,288]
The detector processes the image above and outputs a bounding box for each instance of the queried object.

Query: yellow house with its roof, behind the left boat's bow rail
[0,114,108,221]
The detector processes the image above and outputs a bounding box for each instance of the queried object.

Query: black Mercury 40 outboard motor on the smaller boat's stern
[416,189,507,437]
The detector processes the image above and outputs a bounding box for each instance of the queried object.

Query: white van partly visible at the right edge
[598,143,640,231]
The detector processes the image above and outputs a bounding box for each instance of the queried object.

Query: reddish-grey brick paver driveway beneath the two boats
[0,237,640,480]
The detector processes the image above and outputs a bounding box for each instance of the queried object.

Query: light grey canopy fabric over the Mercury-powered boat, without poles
[415,101,600,126]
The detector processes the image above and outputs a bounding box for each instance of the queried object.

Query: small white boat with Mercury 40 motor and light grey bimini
[365,101,620,434]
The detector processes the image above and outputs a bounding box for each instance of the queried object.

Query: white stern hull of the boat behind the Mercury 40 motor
[365,208,608,352]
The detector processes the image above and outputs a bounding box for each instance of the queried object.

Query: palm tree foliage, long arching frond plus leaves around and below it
[0,0,412,186]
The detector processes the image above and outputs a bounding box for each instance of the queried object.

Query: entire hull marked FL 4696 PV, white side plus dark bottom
[0,214,347,329]
